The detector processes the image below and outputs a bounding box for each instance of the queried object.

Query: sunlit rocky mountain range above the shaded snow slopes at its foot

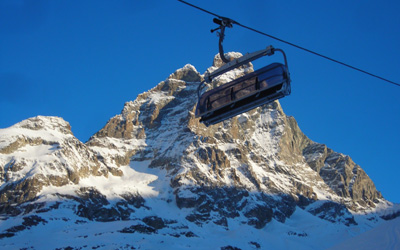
[0,53,392,250]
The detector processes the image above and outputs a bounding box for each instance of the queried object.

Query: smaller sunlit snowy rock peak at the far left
[0,116,109,213]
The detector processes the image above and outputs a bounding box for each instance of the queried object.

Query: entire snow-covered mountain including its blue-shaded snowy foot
[0,53,400,249]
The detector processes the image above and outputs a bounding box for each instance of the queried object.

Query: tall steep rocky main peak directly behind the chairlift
[88,53,385,227]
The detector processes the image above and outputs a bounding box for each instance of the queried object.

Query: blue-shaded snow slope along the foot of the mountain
[0,199,400,250]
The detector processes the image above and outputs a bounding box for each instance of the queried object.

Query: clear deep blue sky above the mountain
[0,0,400,202]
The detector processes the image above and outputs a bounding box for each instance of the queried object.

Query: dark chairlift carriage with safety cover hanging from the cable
[195,46,291,126]
